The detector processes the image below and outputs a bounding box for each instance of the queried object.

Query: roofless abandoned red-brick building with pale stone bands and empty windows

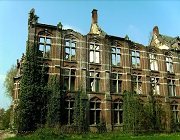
[13,9,180,129]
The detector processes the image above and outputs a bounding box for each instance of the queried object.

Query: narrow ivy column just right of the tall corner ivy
[47,75,66,127]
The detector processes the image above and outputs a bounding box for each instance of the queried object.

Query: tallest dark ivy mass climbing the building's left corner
[17,27,47,133]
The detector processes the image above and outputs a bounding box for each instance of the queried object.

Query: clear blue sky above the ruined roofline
[0,0,180,109]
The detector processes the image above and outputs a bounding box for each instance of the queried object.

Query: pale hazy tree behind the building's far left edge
[4,65,17,98]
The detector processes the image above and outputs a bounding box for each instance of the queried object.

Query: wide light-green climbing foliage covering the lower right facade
[123,92,166,134]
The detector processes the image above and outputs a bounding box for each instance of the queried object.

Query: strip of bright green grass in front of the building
[6,129,180,140]
